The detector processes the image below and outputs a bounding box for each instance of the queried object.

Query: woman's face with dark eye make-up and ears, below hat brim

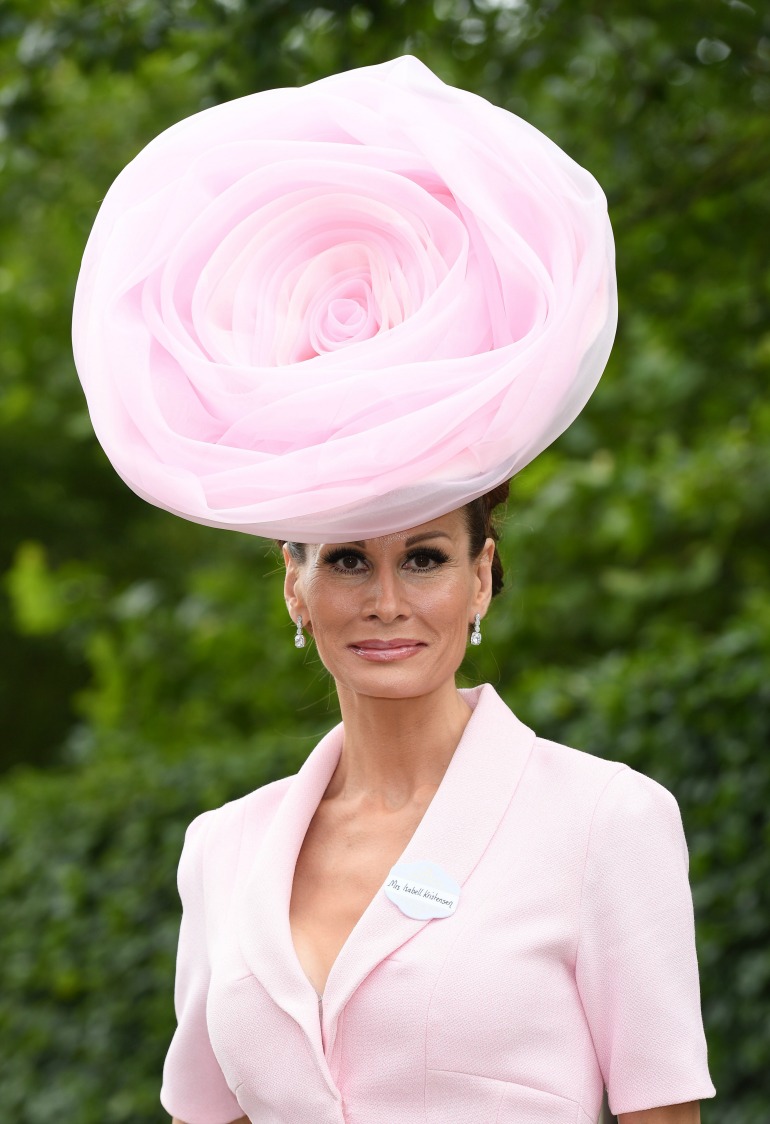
[283,510,495,698]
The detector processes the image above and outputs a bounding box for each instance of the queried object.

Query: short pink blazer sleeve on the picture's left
[161,813,243,1124]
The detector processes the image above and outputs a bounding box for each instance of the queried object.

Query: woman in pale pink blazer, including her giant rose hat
[75,60,715,1124]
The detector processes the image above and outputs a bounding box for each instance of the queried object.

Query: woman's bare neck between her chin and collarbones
[325,680,472,812]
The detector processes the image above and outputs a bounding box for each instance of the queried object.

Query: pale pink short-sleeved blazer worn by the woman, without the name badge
[161,686,715,1124]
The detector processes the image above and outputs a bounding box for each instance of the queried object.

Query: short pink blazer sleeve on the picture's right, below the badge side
[576,768,716,1115]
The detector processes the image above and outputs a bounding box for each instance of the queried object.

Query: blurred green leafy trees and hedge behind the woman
[0,0,770,1124]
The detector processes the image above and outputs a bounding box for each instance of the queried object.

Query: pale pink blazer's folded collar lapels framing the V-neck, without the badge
[237,685,535,1053]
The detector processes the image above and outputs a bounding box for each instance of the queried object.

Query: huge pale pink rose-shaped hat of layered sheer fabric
[73,56,617,543]
